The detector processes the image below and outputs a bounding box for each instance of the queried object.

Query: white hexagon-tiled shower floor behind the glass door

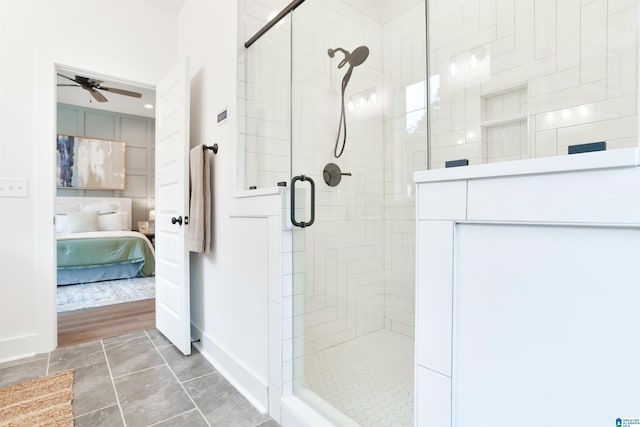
[306,329,414,427]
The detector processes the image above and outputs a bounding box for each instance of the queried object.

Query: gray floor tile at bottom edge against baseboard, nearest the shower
[184,374,269,427]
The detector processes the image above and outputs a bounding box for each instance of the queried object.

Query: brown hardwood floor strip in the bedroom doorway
[58,299,156,347]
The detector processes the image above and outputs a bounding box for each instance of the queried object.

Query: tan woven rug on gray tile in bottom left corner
[0,371,73,427]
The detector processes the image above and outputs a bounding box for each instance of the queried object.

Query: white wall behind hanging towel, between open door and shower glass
[178,0,281,410]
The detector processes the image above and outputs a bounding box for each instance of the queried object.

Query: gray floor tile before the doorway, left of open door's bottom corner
[105,336,164,378]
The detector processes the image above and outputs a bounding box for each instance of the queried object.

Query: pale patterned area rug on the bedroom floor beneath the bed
[56,277,156,313]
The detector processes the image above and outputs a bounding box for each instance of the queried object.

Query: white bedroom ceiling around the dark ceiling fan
[57,68,156,117]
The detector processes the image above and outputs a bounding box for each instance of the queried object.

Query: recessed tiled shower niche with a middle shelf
[480,85,529,163]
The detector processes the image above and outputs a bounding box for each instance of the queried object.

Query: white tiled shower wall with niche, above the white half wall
[429,0,638,168]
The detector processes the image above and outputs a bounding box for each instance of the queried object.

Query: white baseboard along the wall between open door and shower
[191,324,269,414]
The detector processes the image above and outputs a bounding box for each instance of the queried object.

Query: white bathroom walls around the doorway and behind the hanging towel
[0,0,281,416]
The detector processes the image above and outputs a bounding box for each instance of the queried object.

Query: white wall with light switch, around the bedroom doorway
[0,0,177,360]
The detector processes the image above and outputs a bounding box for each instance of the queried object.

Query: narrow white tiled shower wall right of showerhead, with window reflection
[382,2,427,336]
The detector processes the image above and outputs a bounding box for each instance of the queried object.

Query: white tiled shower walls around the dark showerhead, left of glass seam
[239,0,426,368]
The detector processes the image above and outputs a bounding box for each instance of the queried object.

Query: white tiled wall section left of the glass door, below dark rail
[238,0,291,190]
